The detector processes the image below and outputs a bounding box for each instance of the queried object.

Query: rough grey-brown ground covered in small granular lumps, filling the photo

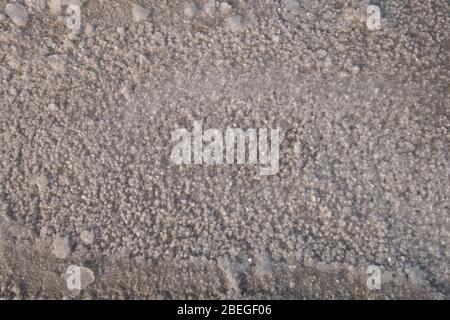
[0,0,450,299]
